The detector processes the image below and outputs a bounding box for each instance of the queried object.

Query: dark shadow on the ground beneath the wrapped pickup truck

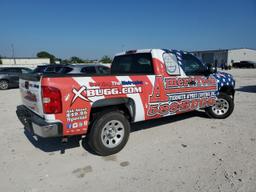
[24,111,208,154]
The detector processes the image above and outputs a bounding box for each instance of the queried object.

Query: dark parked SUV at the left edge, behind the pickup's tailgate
[0,67,32,90]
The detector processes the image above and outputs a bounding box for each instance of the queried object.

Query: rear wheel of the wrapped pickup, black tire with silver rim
[87,111,130,156]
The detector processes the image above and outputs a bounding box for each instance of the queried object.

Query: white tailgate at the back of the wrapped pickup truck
[19,74,44,117]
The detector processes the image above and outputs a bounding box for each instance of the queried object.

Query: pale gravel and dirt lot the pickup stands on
[0,69,256,192]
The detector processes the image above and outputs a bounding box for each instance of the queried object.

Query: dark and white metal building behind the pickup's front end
[192,48,256,67]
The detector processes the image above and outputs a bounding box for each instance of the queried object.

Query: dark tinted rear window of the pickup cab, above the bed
[111,53,154,74]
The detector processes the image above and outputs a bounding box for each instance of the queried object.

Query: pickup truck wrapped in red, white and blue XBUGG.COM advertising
[16,49,235,156]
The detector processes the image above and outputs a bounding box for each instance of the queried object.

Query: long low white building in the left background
[0,57,50,67]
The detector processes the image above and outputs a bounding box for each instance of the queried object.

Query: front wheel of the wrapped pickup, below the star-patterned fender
[205,93,235,119]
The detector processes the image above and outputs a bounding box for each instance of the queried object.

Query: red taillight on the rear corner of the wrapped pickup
[42,86,62,114]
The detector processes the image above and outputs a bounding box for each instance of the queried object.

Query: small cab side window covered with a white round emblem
[163,53,180,75]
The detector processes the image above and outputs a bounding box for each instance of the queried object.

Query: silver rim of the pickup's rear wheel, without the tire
[101,120,124,148]
